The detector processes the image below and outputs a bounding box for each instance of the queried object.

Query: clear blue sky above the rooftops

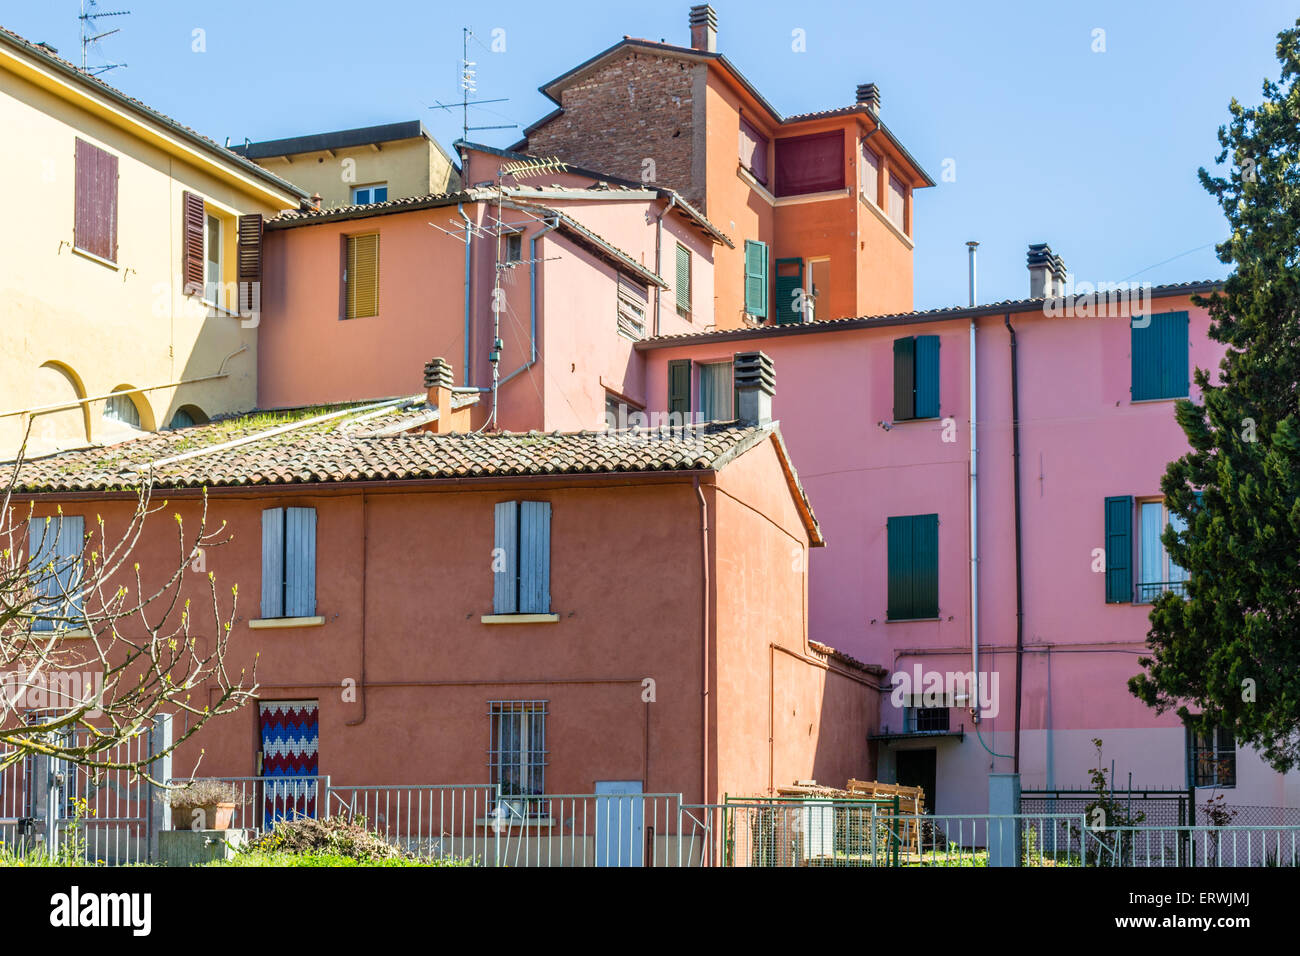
[0,0,1297,308]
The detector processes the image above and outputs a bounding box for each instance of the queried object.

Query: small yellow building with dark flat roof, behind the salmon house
[233,120,460,209]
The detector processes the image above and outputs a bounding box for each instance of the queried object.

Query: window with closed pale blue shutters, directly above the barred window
[491,501,551,614]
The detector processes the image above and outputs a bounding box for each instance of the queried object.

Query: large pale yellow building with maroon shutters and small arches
[0,29,306,458]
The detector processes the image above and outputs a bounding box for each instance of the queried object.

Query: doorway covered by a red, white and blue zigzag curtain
[259,700,320,830]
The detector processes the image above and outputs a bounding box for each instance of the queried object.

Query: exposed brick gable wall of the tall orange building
[528,51,707,202]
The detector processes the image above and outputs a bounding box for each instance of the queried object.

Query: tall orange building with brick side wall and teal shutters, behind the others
[515,5,935,329]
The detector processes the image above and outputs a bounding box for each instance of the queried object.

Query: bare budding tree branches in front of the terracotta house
[0,424,257,783]
